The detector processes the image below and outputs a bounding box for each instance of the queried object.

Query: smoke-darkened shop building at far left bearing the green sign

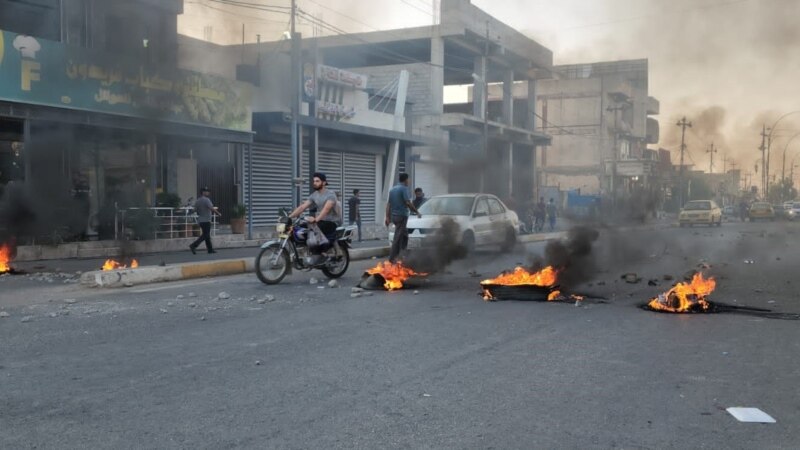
[0,0,252,242]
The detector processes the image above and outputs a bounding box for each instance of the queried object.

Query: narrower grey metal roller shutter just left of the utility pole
[244,145,292,226]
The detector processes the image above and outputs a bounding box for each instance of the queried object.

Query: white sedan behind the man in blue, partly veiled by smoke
[389,194,519,250]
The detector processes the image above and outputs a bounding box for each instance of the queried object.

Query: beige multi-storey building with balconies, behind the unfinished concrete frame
[490,59,659,198]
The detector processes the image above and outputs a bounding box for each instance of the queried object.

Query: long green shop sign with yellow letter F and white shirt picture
[0,30,252,131]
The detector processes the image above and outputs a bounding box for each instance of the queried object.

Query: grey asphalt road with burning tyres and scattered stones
[0,223,800,449]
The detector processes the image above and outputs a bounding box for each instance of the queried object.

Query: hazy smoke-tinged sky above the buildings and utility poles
[179,0,800,178]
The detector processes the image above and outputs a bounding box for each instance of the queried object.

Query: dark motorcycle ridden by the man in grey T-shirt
[256,208,357,284]
